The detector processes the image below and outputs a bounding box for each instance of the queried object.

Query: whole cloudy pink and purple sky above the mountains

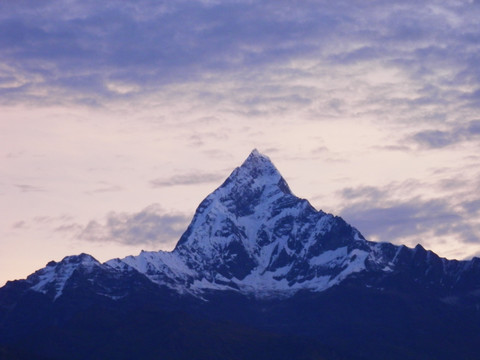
[0,0,480,285]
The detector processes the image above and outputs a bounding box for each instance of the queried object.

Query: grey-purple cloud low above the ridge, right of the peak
[340,180,480,250]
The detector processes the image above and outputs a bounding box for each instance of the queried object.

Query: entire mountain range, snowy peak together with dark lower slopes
[0,150,480,360]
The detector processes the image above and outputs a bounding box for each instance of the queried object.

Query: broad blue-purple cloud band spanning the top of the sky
[0,0,480,115]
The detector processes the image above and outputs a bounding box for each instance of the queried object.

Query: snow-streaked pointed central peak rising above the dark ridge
[110,150,367,296]
